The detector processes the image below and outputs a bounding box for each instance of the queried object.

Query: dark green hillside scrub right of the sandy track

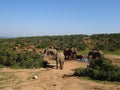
[91,33,120,51]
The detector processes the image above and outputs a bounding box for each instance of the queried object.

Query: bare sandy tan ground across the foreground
[0,56,120,90]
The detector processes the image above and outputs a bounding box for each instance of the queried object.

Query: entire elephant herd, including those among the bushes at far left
[12,44,103,69]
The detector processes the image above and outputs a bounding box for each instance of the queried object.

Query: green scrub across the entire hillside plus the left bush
[0,33,120,68]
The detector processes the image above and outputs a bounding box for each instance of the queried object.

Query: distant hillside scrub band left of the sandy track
[0,35,86,50]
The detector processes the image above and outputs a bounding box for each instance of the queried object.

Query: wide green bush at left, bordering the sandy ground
[0,50,47,68]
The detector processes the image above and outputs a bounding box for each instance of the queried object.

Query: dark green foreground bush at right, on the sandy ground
[74,58,120,81]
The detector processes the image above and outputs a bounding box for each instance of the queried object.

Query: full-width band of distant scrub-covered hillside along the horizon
[0,33,120,51]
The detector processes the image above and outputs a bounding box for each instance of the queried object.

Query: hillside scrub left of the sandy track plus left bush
[0,35,86,68]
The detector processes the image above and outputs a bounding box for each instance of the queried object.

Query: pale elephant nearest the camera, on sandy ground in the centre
[56,52,65,70]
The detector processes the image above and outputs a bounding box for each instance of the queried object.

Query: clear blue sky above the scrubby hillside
[0,0,120,37]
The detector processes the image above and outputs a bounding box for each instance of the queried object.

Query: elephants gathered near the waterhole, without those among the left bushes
[43,48,103,69]
